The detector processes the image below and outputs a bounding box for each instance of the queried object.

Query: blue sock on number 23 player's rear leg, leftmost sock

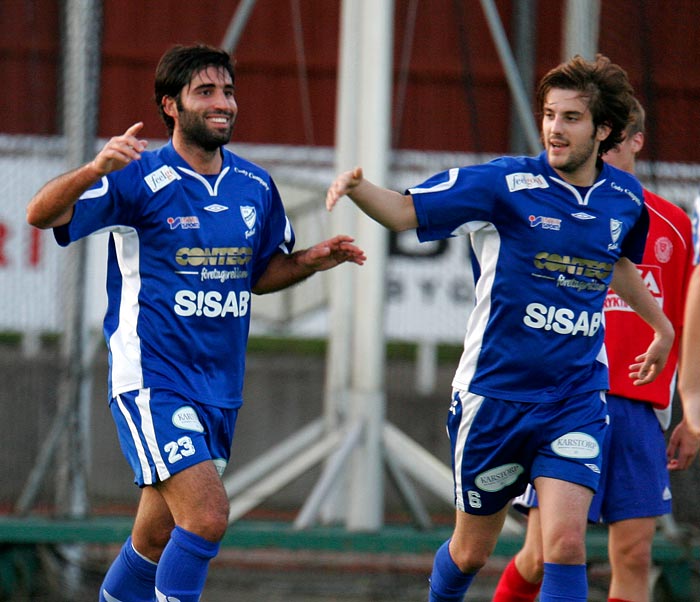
[100,537,158,602]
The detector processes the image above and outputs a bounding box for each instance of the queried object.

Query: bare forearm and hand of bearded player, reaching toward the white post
[253,234,367,295]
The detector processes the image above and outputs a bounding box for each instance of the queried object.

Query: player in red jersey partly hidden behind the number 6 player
[493,102,700,602]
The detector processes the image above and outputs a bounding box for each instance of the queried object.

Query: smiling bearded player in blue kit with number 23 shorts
[27,45,365,602]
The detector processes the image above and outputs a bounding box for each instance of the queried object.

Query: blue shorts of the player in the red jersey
[513,395,671,523]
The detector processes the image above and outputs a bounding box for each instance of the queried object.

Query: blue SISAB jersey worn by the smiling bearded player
[54,143,294,408]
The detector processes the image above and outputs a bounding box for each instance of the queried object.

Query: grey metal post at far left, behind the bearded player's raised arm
[56,0,102,594]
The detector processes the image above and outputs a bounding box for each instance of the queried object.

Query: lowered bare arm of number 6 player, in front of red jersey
[611,257,675,385]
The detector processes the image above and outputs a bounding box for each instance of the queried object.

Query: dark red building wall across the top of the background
[0,0,700,163]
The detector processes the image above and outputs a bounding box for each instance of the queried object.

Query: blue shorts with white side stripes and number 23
[109,389,238,487]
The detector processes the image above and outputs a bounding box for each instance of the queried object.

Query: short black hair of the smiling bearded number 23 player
[154,44,235,136]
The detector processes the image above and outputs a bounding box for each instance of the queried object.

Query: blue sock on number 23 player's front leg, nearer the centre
[157,527,219,602]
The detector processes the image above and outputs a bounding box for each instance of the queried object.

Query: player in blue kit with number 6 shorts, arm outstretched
[326,55,673,602]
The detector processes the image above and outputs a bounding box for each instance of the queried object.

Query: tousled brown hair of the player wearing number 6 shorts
[537,54,634,156]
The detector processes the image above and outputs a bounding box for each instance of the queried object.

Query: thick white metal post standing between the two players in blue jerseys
[347,0,394,530]
